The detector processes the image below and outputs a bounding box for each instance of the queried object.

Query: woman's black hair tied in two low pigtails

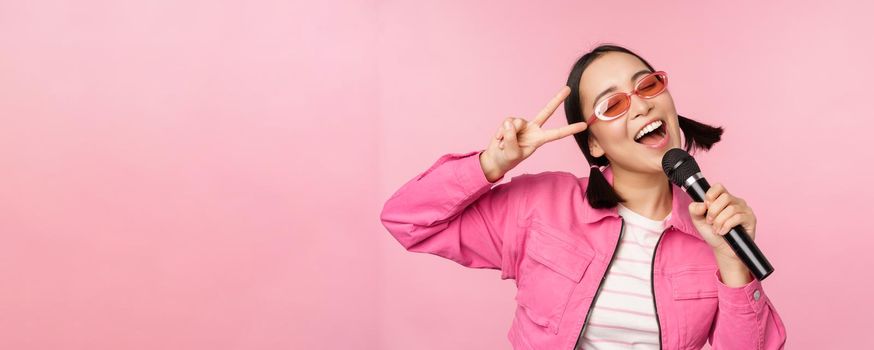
[564,44,723,208]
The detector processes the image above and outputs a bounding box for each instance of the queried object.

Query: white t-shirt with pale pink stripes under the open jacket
[577,204,671,350]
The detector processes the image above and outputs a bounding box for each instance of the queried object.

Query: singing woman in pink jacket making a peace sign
[381,45,786,349]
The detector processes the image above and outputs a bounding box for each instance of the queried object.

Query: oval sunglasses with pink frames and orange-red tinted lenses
[586,71,668,125]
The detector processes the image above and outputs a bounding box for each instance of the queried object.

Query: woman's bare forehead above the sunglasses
[580,52,649,102]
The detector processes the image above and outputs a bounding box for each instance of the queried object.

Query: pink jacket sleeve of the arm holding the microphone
[710,270,786,350]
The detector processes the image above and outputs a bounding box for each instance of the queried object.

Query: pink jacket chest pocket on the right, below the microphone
[670,265,718,349]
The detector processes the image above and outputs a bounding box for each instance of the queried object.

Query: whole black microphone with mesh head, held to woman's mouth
[662,148,774,281]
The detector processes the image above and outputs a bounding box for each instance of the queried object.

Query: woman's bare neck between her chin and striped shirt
[613,166,673,220]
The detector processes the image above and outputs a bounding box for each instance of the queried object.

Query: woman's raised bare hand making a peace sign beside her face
[479,86,588,182]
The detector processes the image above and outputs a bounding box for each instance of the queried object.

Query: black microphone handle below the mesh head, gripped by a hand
[683,173,774,281]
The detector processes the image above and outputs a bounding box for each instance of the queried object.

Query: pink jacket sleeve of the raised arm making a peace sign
[380,150,525,279]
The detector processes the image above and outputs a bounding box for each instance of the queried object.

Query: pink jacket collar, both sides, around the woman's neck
[581,165,703,240]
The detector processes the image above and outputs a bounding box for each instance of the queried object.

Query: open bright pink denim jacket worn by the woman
[380,150,786,350]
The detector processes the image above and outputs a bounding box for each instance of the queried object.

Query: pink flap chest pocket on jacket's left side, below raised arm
[516,228,593,334]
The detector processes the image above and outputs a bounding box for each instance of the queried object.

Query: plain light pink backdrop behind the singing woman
[0,0,874,349]
